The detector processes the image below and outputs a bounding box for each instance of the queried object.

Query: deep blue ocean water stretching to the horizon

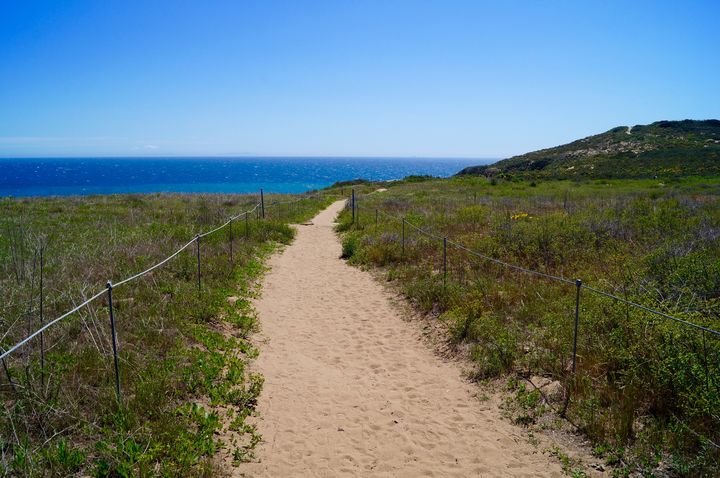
[0,157,491,197]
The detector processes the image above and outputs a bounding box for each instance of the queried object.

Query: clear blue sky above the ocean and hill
[0,0,720,157]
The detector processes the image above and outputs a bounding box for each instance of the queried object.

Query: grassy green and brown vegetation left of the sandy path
[0,195,327,476]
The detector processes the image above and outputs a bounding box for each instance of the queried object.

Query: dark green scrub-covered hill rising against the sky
[458,120,720,178]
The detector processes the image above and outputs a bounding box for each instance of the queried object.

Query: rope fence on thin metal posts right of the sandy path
[348,190,720,430]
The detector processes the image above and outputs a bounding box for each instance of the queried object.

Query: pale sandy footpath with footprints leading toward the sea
[238,201,562,477]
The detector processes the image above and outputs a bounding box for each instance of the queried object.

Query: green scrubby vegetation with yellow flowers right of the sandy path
[339,176,720,476]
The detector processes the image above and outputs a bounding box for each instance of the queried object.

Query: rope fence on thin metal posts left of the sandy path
[0,189,323,401]
